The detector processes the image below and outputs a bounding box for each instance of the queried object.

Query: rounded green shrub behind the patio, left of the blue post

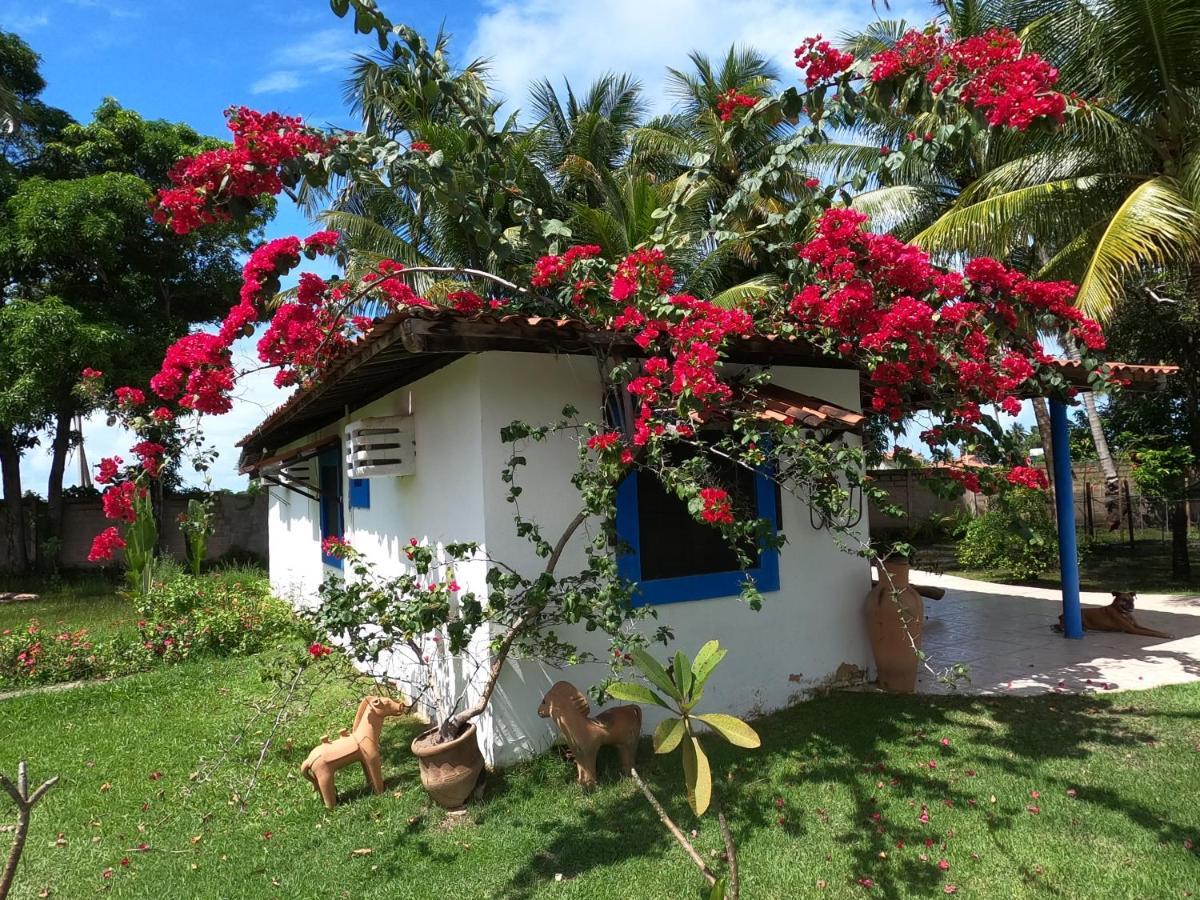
[958,487,1058,580]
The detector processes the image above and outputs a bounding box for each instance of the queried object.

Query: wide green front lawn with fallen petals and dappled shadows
[0,643,1200,900]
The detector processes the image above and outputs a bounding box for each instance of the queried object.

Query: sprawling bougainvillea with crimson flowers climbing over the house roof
[82,0,1108,764]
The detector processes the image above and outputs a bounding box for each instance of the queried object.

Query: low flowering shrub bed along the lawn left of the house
[0,571,299,688]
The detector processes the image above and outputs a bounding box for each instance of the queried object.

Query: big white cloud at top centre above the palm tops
[466,0,923,112]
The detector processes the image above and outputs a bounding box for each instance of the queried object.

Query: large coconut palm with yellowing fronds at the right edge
[840,0,1200,505]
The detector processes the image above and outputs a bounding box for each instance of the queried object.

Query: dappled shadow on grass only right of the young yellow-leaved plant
[729,694,1188,898]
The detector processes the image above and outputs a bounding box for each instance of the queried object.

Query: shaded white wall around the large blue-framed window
[481,353,871,764]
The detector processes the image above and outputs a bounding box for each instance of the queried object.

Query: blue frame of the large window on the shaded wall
[617,470,779,606]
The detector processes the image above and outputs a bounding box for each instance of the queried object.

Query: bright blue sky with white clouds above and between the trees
[0,0,930,494]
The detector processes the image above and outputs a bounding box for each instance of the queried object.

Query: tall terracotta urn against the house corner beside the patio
[866,562,925,694]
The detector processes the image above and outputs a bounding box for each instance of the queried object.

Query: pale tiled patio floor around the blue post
[912,571,1200,694]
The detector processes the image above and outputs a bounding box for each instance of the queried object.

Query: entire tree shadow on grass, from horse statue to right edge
[479,694,1188,900]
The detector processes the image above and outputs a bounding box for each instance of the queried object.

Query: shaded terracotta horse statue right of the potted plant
[538,682,642,787]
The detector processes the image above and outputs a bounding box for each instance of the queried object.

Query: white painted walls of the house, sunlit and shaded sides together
[270,352,870,766]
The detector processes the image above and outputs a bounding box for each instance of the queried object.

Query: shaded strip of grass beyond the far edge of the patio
[914,530,1200,594]
